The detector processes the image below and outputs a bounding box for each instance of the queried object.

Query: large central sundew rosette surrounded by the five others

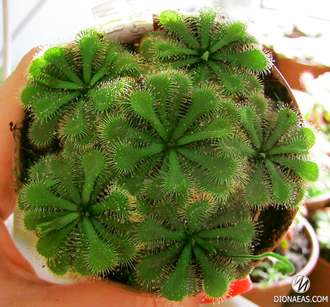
[100,70,243,199]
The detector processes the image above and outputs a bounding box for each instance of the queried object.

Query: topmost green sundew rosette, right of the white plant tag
[141,8,271,93]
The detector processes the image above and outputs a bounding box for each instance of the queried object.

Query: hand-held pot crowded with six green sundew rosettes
[11,8,318,301]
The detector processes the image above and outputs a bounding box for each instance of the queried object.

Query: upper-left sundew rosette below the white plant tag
[21,30,139,146]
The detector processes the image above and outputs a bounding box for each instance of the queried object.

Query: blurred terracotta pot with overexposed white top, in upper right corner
[256,18,330,91]
